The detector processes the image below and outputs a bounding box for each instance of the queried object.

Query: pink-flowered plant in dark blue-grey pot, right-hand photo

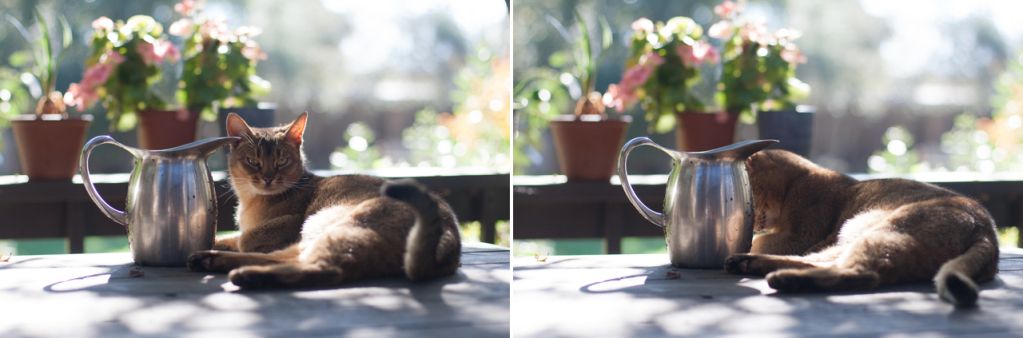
[708,1,813,156]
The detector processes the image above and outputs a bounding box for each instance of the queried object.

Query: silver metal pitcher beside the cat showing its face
[80,135,237,266]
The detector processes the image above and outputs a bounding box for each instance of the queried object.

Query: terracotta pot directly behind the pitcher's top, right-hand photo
[675,112,739,152]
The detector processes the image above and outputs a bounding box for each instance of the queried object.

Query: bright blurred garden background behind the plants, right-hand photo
[513,0,1023,174]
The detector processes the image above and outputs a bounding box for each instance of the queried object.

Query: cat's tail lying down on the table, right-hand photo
[934,236,998,308]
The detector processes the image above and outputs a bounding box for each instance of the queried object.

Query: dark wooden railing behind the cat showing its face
[0,173,510,253]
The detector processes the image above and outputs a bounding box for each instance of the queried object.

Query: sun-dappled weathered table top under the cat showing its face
[0,243,510,337]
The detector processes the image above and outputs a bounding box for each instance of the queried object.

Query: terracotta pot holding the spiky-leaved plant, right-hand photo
[550,116,631,182]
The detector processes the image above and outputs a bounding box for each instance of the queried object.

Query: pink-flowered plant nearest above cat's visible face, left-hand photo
[169,0,274,133]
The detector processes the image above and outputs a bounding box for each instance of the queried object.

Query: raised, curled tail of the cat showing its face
[381,179,461,281]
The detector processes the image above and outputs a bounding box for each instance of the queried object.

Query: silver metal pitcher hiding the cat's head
[618,137,777,268]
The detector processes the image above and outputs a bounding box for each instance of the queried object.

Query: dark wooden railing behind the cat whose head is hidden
[512,173,1023,254]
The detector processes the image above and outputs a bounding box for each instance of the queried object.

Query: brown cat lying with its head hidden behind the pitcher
[724,150,998,307]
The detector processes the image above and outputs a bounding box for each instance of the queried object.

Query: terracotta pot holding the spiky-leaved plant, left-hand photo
[10,115,92,180]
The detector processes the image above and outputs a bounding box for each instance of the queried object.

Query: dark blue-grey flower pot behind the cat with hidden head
[757,105,815,157]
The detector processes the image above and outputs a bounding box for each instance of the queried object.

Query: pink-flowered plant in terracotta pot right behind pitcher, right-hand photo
[605,16,738,151]
